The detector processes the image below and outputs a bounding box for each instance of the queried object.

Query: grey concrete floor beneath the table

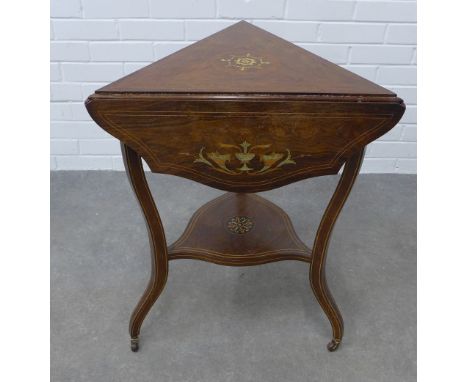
[51,172,416,382]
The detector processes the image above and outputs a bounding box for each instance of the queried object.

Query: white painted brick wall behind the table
[50,0,417,173]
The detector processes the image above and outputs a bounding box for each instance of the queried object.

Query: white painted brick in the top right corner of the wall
[355,1,416,22]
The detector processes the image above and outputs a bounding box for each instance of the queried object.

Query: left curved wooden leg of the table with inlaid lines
[121,143,168,351]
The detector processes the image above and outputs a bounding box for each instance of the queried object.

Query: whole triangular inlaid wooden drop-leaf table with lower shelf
[85,22,405,351]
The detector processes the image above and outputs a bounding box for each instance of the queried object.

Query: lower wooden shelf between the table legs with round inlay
[169,193,311,266]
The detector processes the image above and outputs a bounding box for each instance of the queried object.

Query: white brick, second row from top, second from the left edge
[119,20,184,40]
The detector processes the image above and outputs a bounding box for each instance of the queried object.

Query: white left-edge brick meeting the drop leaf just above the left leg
[50,121,112,139]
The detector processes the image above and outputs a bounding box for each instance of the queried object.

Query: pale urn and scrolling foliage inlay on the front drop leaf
[194,141,296,175]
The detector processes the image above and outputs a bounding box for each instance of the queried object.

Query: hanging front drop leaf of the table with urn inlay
[86,94,404,192]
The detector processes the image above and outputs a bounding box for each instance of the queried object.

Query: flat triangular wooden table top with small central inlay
[96,21,395,97]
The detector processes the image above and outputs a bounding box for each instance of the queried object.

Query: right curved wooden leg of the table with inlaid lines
[309,149,364,351]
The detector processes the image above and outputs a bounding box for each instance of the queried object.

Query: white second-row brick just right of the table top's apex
[254,21,319,42]
